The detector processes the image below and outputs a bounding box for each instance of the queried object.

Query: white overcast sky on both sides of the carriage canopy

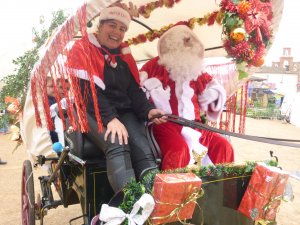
[0,0,300,76]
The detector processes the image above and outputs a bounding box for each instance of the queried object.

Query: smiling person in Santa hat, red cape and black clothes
[66,5,164,192]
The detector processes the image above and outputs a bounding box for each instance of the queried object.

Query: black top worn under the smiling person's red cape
[80,47,155,126]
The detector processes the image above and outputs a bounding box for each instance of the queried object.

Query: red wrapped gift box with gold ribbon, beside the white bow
[151,173,202,224]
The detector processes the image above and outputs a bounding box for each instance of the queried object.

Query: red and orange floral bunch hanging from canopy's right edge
[220,0,273,72]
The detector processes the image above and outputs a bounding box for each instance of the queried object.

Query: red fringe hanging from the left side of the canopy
[31,4,103,132]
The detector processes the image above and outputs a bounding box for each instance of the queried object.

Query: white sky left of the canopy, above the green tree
[0,0,84,76]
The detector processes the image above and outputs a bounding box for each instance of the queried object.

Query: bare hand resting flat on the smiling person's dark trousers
[104,118,128,145]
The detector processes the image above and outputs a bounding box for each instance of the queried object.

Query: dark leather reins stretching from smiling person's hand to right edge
[155,114,300,148]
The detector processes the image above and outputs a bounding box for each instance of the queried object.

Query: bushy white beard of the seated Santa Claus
[159,43,203,83]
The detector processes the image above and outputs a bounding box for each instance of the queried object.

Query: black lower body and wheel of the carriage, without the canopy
[21,114,262,225]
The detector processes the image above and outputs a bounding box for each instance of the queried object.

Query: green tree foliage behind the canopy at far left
[0,10,67,106]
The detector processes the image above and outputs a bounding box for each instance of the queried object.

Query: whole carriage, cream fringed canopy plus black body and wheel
[22,0,283,225]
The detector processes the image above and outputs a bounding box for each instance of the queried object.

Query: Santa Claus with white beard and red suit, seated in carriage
[140,25,234,170]
